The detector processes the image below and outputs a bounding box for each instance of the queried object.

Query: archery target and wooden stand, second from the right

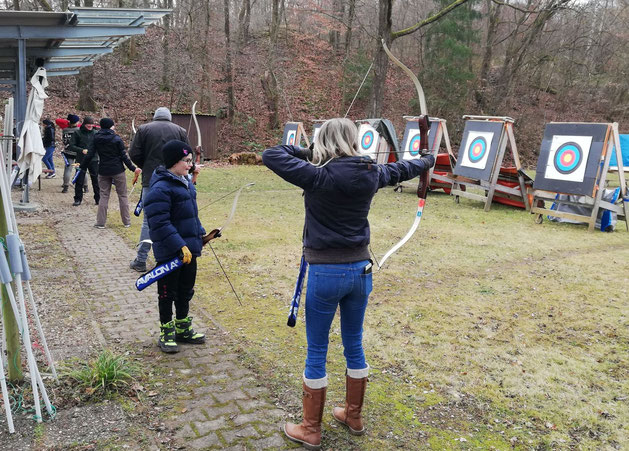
[450,115,532,211]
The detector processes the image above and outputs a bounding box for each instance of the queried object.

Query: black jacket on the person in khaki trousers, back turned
[81,128,135,176]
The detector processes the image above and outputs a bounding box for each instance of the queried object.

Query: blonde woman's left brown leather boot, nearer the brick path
[284,382,327,449]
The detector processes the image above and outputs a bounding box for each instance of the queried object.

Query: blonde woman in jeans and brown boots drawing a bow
[262,119,435,449]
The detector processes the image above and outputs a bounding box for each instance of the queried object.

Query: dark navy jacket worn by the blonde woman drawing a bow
[262,145,434,263]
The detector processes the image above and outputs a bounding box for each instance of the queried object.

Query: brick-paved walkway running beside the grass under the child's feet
[17,179,290,449]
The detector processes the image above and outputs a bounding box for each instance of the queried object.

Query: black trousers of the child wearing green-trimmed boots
[157,257,197,324]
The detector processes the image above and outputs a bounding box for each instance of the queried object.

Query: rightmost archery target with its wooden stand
[531,122,629,231]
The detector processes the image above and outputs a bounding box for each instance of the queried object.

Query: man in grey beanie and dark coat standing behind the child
[129,107,188,272]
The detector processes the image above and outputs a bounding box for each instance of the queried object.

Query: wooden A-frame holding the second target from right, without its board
[450,115,531,211]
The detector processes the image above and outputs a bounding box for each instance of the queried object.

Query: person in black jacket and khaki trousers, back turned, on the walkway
[80,117,142,229]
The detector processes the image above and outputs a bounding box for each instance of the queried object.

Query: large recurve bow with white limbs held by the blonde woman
[378,39,430,269]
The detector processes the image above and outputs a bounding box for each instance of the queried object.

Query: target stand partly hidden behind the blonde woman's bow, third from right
[395,116,456,193]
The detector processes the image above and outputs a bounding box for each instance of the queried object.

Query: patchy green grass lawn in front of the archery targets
[121,167,629,450]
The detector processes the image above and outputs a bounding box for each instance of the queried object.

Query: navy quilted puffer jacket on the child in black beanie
[144,166,205,263]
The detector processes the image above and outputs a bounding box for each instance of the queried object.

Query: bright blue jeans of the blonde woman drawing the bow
[305,260,372,379]
